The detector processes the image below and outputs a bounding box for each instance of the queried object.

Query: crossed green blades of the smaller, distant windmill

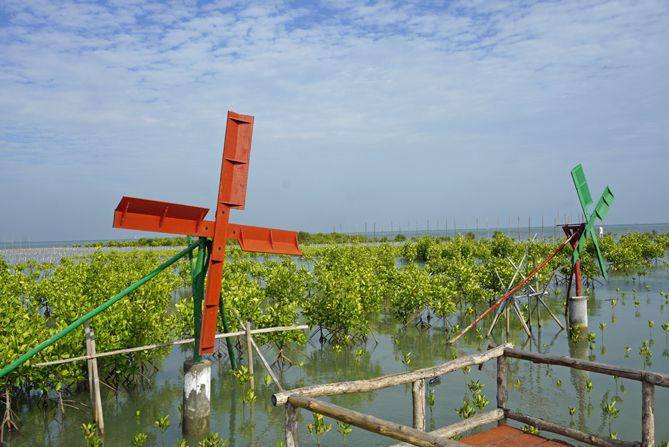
[571,164,614,279]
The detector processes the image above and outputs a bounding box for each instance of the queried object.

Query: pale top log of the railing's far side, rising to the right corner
[272,344,511,406]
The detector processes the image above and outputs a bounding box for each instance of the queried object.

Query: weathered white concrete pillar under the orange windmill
[182,359,211,437]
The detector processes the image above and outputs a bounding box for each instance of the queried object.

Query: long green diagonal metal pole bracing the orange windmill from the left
[0,242,198,377]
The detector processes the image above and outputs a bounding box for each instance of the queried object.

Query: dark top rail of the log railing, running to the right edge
[504,348,669,388]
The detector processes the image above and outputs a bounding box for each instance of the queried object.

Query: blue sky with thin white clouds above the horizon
[0,0,669,241]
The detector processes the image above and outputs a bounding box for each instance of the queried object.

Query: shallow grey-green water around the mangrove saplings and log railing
[7,267,669,447]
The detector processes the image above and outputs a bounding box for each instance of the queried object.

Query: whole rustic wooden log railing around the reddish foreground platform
[272,344,669,447]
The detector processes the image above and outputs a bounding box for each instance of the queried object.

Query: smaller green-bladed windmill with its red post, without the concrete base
[562,164,614,296]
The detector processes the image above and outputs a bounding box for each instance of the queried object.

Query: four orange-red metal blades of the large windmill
[113,112,302,354]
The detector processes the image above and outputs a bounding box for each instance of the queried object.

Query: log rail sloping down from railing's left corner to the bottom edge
[289,394,465,447]
